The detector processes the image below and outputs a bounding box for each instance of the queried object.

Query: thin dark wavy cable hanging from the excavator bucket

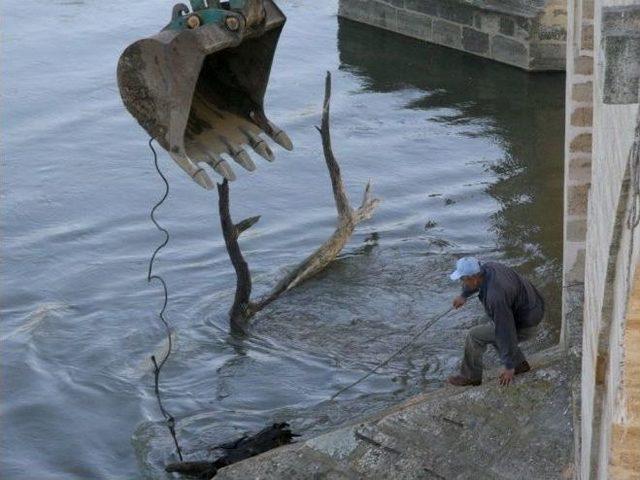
[147,138,182,461]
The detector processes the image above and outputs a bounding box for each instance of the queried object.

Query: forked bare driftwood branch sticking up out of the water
[218,72,379,326]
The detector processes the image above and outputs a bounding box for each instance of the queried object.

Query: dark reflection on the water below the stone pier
[338,19,565,332]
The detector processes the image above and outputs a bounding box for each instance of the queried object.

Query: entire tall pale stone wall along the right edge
[561,0,640,480]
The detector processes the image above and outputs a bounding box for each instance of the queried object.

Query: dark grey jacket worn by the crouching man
[462,262,544,369]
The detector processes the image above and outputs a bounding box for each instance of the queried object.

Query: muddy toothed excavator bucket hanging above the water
[118,0,293,189]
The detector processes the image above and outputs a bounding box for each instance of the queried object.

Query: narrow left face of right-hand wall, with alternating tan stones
[560,0,595,478]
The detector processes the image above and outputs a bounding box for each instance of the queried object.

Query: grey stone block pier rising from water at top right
[338,0,567,70]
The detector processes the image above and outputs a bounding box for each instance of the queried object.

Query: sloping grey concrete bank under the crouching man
[215,349,575,480]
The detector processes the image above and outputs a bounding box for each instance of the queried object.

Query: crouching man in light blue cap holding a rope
[448,257,544,386]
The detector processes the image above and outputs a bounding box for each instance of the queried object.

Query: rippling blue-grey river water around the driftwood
[0,0,564,480]
